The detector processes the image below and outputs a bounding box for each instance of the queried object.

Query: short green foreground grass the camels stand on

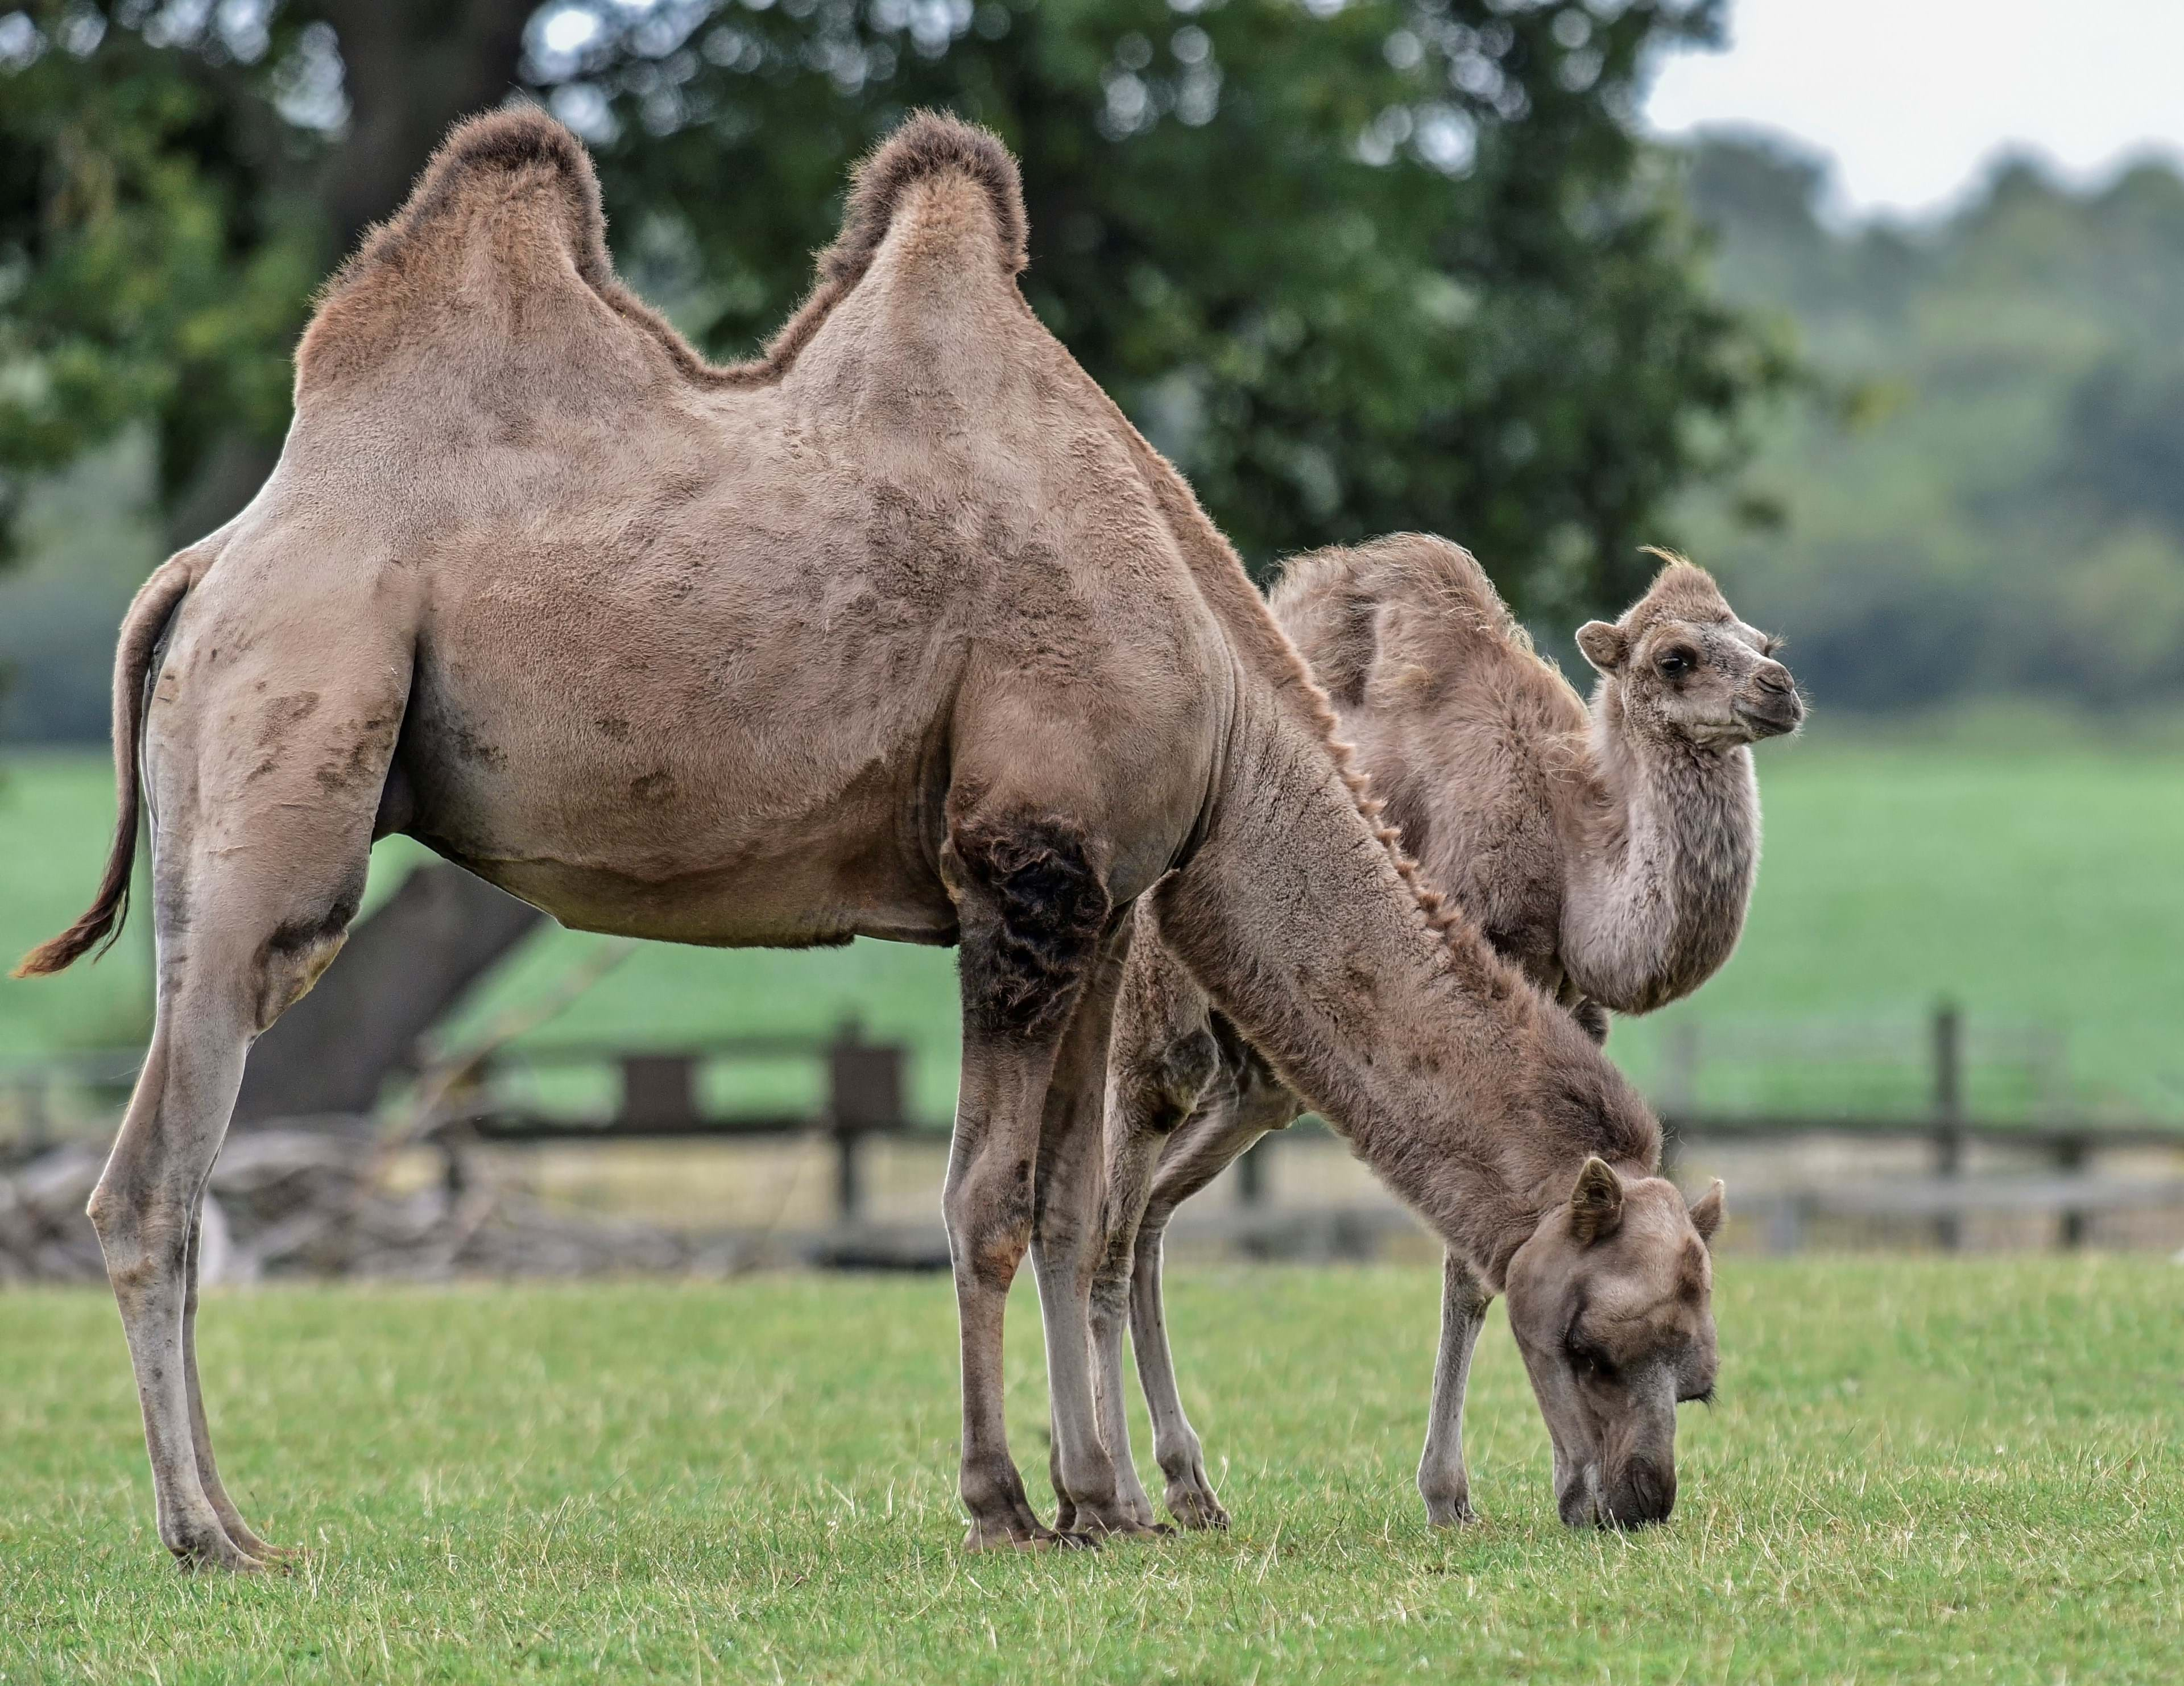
[0,1258,2184,1686]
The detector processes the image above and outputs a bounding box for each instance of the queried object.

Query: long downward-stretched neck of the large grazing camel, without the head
[1153,681,1660,1286]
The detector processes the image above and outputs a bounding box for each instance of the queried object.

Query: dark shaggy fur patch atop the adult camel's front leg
[950,819,1107,1042]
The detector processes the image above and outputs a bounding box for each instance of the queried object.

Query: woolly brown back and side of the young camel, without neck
[1271,533,1588,985]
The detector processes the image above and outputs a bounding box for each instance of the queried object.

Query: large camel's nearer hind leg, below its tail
[89,638,406,1571]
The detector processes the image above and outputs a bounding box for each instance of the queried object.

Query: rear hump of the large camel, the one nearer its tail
[297,105,621,391]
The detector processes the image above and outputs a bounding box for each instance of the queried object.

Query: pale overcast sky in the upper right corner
[1647,0,2184,212]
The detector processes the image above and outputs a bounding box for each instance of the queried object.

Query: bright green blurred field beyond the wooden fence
[0,721,2184,1118]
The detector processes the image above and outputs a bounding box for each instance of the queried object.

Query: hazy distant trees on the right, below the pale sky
[1690,138,2184,710]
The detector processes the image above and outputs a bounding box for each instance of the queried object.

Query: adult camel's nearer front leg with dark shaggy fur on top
[941,819,1107,1548]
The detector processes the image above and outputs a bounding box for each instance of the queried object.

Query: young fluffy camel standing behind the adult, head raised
[1092,535,1804,1527]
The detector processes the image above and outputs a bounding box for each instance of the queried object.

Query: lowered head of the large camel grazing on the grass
[1505,1158,1721,1529]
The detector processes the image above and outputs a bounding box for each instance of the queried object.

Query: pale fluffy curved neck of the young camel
[1562,684,1760,1013]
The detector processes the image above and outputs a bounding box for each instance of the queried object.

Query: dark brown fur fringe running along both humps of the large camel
[297,105,1029,387]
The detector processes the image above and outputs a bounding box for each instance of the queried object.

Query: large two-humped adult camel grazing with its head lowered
[24,109,1714,1571]
